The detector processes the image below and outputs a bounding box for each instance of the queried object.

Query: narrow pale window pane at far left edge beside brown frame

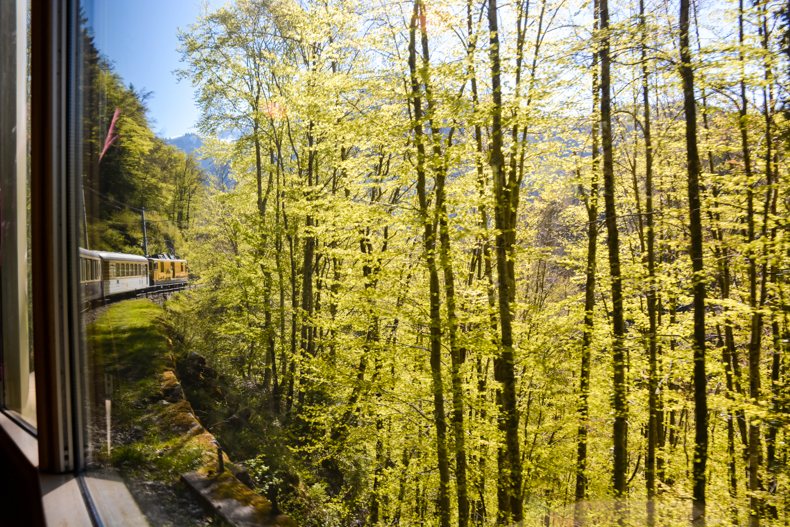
[0,0,36,427]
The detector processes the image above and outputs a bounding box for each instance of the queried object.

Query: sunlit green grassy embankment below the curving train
[88,300,278,525]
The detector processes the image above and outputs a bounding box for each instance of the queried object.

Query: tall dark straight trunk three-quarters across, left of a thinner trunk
[600,0,628,524]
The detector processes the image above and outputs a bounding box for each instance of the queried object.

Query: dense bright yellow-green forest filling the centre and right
[164,0,790,527]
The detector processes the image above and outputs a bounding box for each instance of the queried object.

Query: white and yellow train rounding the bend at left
[80,248,189,304]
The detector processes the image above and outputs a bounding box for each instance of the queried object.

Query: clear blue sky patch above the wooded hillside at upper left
[88,0,226,137]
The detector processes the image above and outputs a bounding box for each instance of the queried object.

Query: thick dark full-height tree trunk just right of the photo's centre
[488,0,523,525]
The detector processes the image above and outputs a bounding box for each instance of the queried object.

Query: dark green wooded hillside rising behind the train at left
[80,32,208,254]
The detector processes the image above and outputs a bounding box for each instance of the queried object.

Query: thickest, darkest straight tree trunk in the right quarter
[680,0,708,526]
